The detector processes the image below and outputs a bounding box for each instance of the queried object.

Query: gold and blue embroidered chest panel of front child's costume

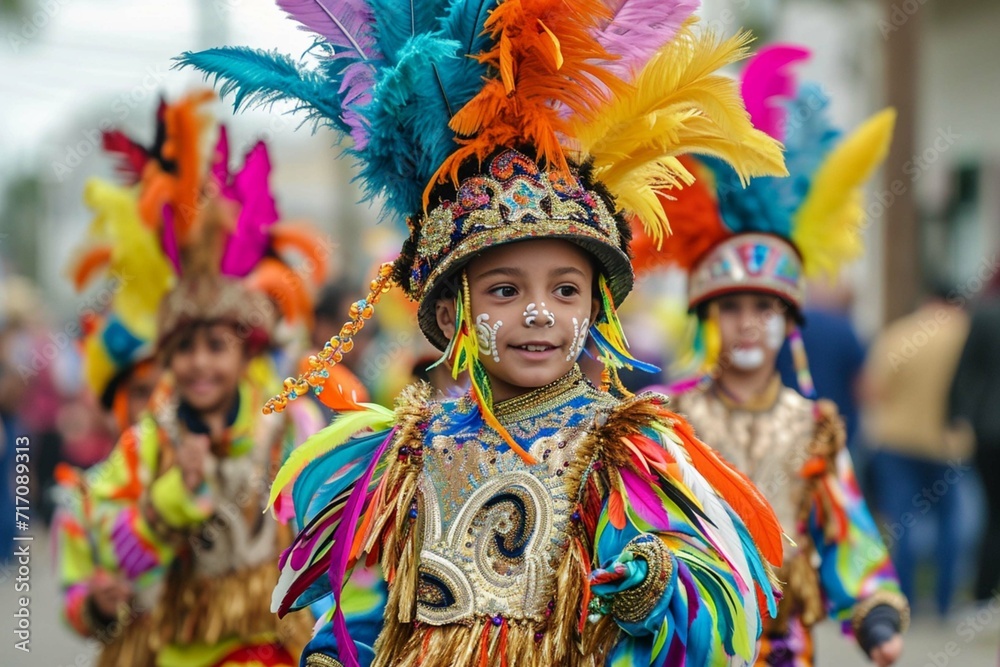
[416,371,614,625]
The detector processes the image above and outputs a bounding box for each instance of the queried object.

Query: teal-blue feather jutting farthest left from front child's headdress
[170,47,350,132]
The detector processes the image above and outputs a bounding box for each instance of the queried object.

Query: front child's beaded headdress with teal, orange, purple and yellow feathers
[180,0,784,416]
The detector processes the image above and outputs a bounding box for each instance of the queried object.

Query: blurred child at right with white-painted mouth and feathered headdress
[664,46,908,666]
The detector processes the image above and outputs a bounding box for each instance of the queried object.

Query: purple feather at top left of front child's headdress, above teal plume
[278,0,381,60]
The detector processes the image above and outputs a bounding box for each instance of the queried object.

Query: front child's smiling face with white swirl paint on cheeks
[438,239,599,401]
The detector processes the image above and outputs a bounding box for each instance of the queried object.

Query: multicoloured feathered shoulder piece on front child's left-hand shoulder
[270,385,430,660]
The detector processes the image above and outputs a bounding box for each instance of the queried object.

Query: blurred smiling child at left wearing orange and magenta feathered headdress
[53,93,368,667]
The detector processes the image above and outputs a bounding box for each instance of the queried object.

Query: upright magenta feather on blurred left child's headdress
[220,141,278,278]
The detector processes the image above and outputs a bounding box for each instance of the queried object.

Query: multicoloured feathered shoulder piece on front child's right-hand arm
[581,394,783,666]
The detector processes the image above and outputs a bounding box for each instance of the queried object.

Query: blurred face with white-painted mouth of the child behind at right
[716,293,788,373]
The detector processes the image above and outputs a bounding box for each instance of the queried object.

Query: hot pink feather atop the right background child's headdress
[742,44,810,141]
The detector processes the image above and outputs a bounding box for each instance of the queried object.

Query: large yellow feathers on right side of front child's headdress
[574,21,787,250]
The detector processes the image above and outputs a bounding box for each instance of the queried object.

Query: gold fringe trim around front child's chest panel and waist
[370,387,680,667]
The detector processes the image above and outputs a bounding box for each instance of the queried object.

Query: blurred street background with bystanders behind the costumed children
[0,0,1000,667]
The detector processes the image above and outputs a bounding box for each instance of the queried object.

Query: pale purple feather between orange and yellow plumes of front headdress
[594,0,701,81]
